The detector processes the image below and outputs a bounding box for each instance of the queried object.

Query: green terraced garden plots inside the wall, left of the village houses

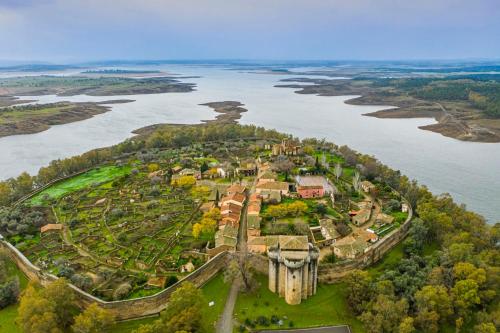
[14,161,211,300]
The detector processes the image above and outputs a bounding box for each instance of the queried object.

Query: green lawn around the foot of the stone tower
[234,275,364,333]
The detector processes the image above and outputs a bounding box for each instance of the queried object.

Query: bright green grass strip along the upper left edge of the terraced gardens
[29,166,130,206]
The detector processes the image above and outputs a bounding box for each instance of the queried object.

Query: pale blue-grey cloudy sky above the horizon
[0,0,500,62]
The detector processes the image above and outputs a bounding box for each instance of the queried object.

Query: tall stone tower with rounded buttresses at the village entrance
[267,236,319,304]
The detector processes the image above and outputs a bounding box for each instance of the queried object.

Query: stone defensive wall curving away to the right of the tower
[318,202,413,283]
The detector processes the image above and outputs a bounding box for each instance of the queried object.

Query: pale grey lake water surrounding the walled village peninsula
[0,65,500,223]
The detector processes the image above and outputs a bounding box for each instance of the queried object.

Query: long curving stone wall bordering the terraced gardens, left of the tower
[0,237,230,320]
